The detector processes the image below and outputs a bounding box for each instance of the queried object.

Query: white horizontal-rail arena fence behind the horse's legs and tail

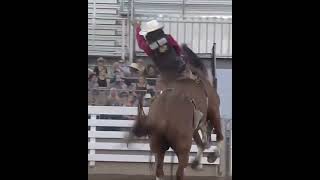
[88,106,225,169]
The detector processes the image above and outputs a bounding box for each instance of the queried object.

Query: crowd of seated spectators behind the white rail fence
[88,57,158,106]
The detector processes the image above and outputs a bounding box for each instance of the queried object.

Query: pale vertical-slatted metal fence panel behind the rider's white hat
[135,17,232,58]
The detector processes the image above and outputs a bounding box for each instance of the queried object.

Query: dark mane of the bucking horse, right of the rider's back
[181,44,208,77]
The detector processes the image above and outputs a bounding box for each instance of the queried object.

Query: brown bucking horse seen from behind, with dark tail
[127,46,223,180]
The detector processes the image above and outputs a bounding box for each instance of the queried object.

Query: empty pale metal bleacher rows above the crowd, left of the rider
[88,0,128,59]
